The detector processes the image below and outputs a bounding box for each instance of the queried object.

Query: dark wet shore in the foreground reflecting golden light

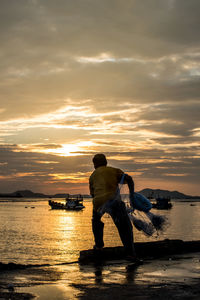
[0,252,200,300]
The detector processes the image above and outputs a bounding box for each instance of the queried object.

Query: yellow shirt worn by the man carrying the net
[89,166,124,211]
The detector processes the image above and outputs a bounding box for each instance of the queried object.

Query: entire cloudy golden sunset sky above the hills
[0,0,200,195]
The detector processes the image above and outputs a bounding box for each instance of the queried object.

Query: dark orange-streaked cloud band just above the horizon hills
[0,145,199,193]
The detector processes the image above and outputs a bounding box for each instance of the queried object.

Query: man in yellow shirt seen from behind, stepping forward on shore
[89,154,136,259]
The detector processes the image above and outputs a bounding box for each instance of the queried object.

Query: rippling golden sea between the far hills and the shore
[0,199,200,264]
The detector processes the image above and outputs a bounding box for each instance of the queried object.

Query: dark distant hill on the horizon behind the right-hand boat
[139,189,200,199]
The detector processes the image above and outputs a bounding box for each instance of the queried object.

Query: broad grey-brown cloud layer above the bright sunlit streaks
[1,0,199,118]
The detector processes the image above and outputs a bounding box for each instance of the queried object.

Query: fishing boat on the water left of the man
[49,195,85,210]
